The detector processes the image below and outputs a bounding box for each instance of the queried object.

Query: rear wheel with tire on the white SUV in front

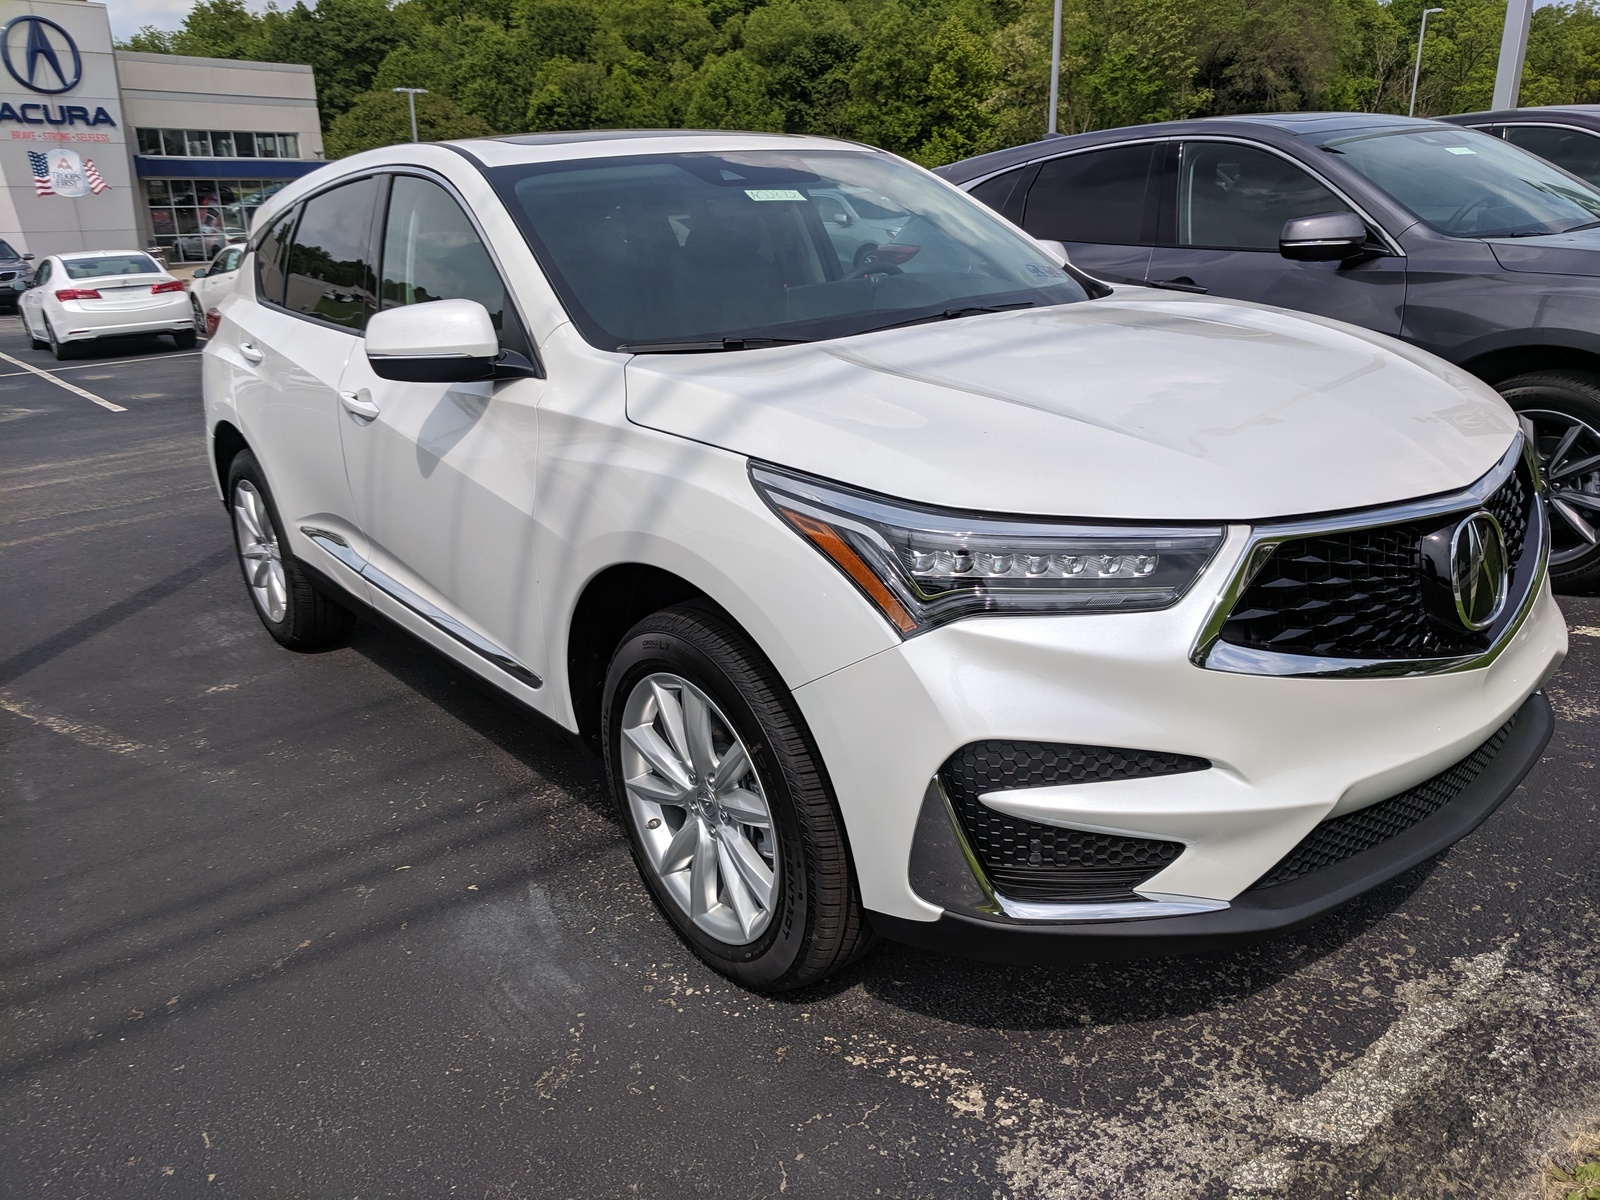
[227,450,355,650]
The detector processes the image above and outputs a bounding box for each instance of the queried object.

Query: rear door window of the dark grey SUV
[1022,142,1155,246]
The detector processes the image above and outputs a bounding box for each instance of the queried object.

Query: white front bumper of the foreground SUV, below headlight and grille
[795,528,1566,954]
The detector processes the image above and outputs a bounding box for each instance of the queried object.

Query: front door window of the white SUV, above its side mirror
[381,174,515,341]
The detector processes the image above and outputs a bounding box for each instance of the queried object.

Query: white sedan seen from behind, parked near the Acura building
[19,250,195,358]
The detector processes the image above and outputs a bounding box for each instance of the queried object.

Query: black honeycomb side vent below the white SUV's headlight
[939,741,1211,902]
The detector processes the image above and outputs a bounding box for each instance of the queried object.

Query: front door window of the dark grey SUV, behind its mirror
[1178,142,1349,251]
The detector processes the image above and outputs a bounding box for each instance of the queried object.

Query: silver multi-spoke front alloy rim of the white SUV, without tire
[621,672,778,946]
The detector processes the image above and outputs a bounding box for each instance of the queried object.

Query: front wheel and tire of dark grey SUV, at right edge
[1498,371,1600,592]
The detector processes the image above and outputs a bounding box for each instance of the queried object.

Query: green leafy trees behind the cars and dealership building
[123,0,1600,165]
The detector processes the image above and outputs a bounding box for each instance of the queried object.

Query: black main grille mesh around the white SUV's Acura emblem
[1219,462,1533,659]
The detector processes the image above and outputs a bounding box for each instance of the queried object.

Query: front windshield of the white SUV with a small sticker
[490,150,1094,350]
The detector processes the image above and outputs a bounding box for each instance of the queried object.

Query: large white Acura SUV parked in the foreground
[205,133,1566,990]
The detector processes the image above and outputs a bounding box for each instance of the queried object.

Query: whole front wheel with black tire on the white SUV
[602,603,874,992]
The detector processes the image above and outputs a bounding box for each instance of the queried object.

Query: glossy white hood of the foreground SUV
[627,288,1517,520]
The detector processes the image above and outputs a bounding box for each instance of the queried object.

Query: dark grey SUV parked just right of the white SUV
[939,112,1600,589]
